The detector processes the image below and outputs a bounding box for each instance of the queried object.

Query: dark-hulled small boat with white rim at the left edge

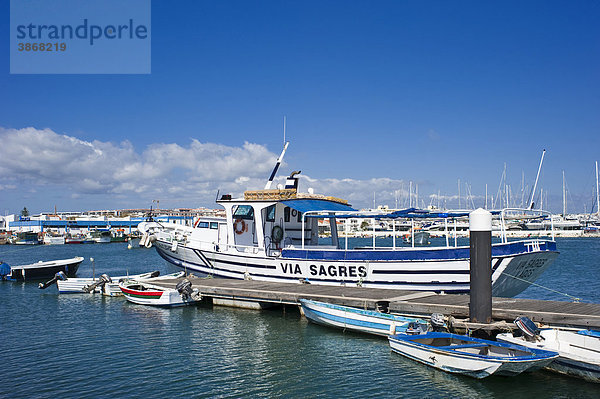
[0,256,83,280]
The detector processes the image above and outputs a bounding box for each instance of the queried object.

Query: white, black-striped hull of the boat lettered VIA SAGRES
[154,236,558,297]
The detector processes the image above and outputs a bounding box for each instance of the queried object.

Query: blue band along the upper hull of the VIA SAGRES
[281,241,556,261]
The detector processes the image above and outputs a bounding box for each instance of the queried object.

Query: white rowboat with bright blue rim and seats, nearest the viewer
[388,332,558,378]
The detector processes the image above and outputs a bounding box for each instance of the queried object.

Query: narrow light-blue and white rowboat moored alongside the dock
[300,299,429,336]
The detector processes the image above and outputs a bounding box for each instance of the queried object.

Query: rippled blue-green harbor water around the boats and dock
[0,238,600,399]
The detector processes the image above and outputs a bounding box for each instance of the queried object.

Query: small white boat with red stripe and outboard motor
[119,279,202,307]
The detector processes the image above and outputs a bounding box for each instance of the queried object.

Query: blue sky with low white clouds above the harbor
[0,0,600,214]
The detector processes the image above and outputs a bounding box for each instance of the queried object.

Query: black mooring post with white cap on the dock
[469,208,492,323]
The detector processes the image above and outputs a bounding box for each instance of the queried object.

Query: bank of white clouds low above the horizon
[0,127,424,208]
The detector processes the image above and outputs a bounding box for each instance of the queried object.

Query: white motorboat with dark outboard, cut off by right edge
[496,317,600,382]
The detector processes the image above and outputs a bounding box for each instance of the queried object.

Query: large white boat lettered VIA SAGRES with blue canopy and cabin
[143,145,558,297]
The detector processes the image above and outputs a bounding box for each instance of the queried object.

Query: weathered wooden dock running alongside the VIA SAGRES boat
[155,276,600,330]
